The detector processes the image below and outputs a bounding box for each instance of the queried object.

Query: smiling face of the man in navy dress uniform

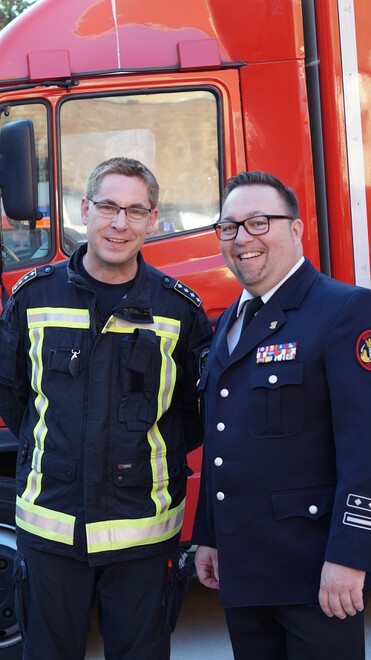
[220,184,303,296]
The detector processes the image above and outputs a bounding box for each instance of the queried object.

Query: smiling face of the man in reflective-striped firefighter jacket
[81,174,158,284]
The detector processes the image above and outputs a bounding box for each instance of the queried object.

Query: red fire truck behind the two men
[0,0,371,660]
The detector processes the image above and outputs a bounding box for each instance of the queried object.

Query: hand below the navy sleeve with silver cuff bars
[319,561,366,619]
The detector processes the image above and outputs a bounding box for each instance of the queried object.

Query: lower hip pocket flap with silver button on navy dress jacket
[271,487,335,520]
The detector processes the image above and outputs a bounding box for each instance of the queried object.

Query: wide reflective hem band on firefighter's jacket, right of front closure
[86,500,185,553]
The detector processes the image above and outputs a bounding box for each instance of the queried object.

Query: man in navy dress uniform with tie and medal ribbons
[194,172,371,660]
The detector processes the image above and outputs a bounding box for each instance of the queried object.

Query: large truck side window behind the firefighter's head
[60,90,219,254]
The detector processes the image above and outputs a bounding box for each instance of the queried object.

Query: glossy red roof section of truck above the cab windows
[0,0,304,84]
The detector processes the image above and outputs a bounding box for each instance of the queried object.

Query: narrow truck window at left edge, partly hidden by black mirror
[0,103,51,271]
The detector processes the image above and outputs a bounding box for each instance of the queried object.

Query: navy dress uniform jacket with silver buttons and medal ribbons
[194,261,371,607]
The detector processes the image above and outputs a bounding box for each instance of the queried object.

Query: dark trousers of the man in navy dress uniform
[225,605,365,660]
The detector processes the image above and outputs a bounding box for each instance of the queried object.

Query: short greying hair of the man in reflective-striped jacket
[86,156,159,209]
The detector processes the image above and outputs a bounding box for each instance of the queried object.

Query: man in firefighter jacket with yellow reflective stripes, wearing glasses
[0,158,211,660]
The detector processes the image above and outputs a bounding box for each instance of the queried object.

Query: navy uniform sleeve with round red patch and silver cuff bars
[325,289,371,571]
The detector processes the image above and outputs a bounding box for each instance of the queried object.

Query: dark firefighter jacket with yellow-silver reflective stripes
[0,246,211,565]
